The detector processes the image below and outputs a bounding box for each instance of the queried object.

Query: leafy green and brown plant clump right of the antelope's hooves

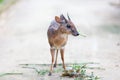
[62,63,104,80]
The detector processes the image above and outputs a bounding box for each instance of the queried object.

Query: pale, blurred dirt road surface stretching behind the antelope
[0,0,120,80]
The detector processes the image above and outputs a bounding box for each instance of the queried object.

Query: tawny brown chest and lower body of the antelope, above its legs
[48,28,68,49]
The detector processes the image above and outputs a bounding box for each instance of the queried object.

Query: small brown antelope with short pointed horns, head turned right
[47,14,79,76]
